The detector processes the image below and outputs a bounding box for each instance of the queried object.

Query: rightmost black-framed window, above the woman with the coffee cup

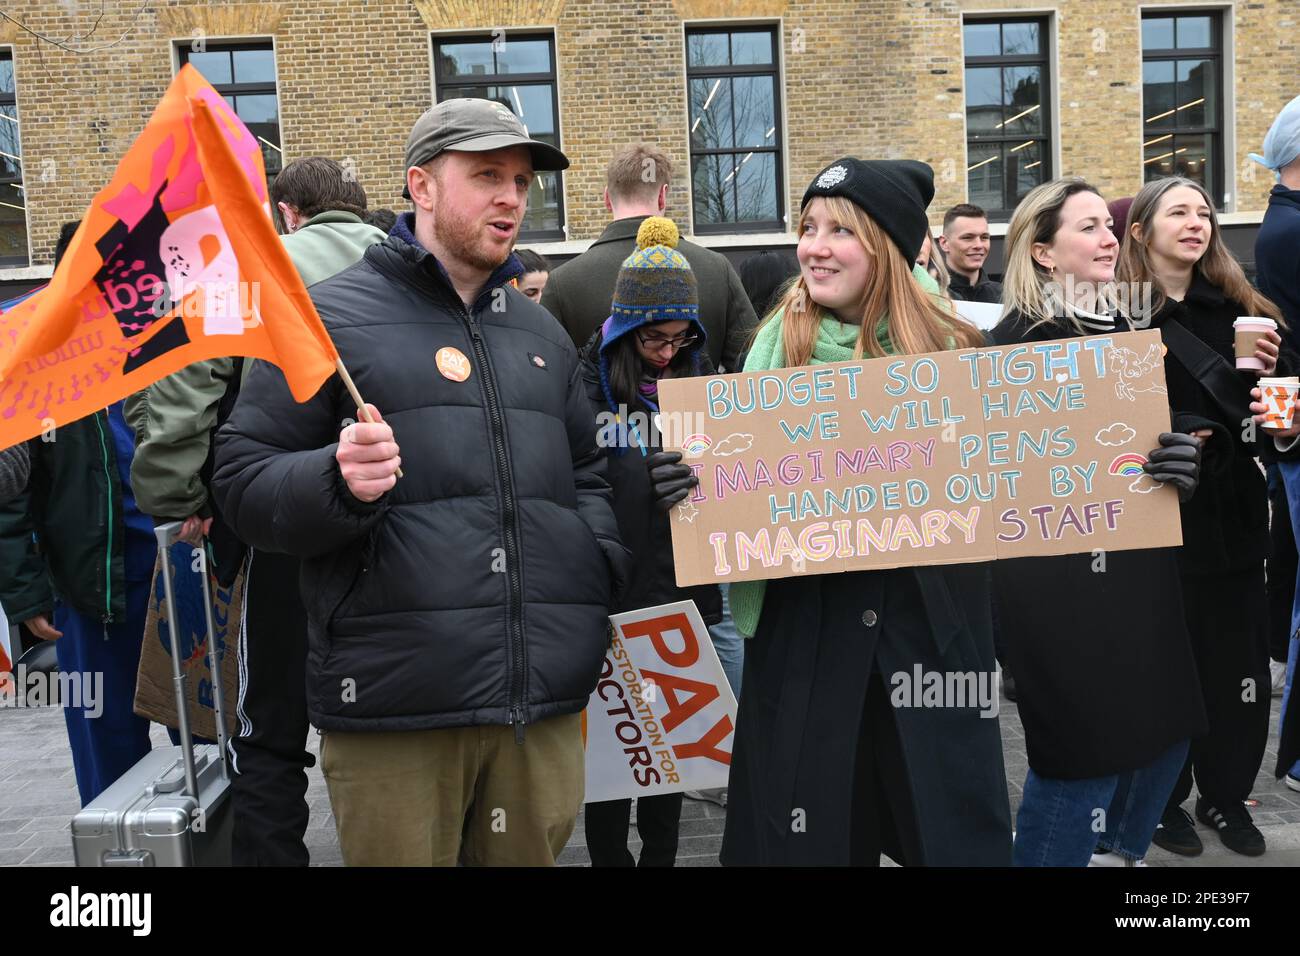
[1141,10,1225,209]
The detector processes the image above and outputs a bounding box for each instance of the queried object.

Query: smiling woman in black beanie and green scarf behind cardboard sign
[722,157,1010,866]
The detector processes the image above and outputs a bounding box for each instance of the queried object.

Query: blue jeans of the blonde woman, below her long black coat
[1013,740,1188,866]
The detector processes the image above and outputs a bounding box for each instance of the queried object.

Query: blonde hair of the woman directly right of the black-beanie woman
[1002,178,1118,336]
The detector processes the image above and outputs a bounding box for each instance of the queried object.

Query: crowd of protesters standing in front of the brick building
[0,89,1300,866]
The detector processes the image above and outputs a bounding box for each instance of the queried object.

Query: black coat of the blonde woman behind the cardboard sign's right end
[993,312,1206,779]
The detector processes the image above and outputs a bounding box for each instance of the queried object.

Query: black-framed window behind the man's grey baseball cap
[433,31,564,241]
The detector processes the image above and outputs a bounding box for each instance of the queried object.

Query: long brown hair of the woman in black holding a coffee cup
[1115,176,1284,326]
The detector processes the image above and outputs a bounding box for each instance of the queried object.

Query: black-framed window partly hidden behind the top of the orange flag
[179,40,285,183]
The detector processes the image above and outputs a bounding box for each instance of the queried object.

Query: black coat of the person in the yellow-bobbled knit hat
[582,330,723,624]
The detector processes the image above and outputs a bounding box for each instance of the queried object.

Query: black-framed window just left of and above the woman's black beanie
[686,26,785,233]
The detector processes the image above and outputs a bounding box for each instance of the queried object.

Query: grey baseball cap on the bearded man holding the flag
[402,98,568,199]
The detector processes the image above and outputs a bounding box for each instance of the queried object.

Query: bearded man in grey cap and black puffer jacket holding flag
[216,99,627,866]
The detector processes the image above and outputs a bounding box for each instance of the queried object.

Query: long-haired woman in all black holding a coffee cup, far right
[1117,177,1294,856]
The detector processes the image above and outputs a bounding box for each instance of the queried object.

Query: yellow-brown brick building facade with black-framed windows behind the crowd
[0,0,1300,280]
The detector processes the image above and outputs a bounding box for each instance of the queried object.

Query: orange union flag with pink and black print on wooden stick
[0,64,338,447]
